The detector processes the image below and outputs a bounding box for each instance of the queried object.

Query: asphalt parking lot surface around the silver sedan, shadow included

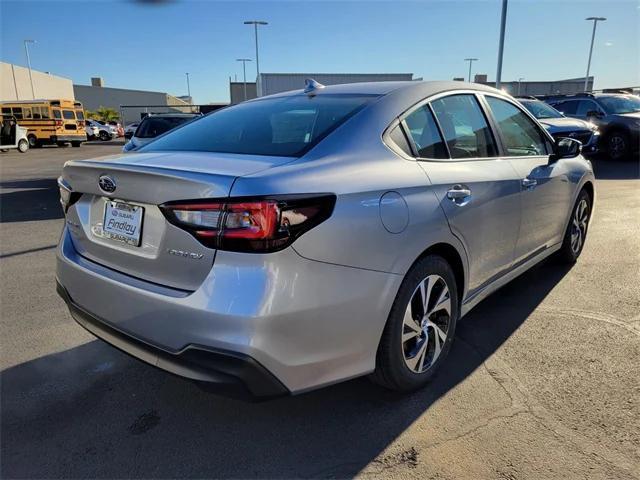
[0,142,640,479]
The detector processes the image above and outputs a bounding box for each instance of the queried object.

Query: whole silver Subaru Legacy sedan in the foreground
[57,81,595,397]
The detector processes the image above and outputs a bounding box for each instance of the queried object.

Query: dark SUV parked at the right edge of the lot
[547,93,640,160]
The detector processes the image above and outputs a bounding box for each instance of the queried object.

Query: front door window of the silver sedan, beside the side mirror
[485,97,547,157]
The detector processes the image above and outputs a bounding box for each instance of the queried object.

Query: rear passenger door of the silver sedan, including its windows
[403,93,520,295]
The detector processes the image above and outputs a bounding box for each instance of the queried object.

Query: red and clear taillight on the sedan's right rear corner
[160,194,336,253]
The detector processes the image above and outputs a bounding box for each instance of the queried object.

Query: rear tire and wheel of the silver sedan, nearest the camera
[371,255,459,392]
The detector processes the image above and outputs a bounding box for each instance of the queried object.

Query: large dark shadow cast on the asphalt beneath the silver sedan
[0,261,569,478]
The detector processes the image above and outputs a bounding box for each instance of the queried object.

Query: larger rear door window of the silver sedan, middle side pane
[431,94,498,158]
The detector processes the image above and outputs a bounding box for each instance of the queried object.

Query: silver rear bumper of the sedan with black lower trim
[57,228,402,396]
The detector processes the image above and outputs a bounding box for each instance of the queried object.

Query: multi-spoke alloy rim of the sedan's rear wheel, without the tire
[402,275,451,373]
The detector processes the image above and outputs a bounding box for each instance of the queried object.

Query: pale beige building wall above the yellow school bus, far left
[0,62,75,100]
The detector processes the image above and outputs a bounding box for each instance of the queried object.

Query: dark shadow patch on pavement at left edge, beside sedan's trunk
[0,178,64,223]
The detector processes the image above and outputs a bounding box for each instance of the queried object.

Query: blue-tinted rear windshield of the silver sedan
[136,94,377,157]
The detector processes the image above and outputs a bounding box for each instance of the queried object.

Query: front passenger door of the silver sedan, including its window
[484,95,572,263]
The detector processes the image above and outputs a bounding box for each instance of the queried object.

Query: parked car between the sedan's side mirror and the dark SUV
[518,97,600,154]
